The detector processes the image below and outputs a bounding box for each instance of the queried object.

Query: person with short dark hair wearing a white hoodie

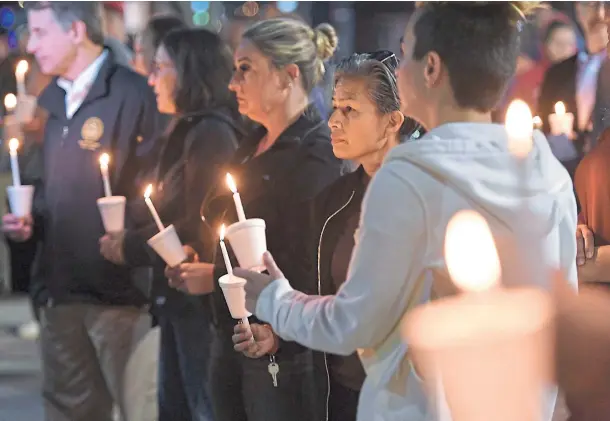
[235,2,577,421]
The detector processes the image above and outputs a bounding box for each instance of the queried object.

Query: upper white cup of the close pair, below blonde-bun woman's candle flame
[227,218,267,270]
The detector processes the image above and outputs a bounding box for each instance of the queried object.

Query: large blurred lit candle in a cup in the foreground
[402,210,554,421]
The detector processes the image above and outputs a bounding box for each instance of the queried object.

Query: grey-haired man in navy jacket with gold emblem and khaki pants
[3,2,158,421]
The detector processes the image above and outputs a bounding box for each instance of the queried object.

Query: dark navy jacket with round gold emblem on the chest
[33,52,160,305]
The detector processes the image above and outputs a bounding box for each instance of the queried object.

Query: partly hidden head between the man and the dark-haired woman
[132,15,186,77]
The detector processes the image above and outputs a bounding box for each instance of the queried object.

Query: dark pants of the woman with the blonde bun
[210,328,326,421]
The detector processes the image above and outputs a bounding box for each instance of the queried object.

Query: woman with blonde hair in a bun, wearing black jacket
[167,19,341,421]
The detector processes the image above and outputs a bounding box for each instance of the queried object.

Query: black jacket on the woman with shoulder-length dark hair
[123,108,244,312]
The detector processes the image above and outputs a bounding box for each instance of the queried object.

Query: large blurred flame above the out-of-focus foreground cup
[445,210,500,291]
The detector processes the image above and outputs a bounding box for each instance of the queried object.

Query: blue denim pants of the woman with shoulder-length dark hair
[158,308,214,421]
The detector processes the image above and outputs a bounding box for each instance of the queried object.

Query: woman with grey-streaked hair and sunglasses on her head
[228,51,416,421]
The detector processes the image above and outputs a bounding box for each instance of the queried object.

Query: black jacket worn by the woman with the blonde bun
[202,106,342,355]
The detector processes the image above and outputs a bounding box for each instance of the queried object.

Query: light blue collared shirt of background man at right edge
[576,49,607,131]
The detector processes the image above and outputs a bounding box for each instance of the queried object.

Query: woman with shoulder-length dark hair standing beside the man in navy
[101,29,242,421]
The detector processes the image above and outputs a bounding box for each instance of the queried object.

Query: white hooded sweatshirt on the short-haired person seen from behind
[256,123,577,421]
